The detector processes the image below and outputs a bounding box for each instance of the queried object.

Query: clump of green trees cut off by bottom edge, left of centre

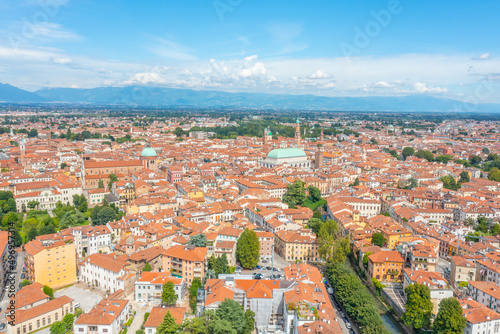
[156,299,255,334]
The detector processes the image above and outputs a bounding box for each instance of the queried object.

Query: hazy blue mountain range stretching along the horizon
[0,84,500,113]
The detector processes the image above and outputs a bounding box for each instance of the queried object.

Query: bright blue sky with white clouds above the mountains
[0,0,500,103]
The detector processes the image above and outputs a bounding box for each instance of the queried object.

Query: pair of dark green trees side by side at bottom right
[401,283,467,334]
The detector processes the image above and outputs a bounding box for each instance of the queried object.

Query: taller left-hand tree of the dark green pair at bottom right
[401,283,433,329]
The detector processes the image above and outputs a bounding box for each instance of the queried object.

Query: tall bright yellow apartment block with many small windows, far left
[24,240,76,288]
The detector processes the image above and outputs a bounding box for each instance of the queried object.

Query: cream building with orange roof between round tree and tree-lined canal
[274,229,323,262]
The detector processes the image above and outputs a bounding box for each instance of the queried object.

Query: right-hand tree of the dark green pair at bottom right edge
[432,297,467,334]
